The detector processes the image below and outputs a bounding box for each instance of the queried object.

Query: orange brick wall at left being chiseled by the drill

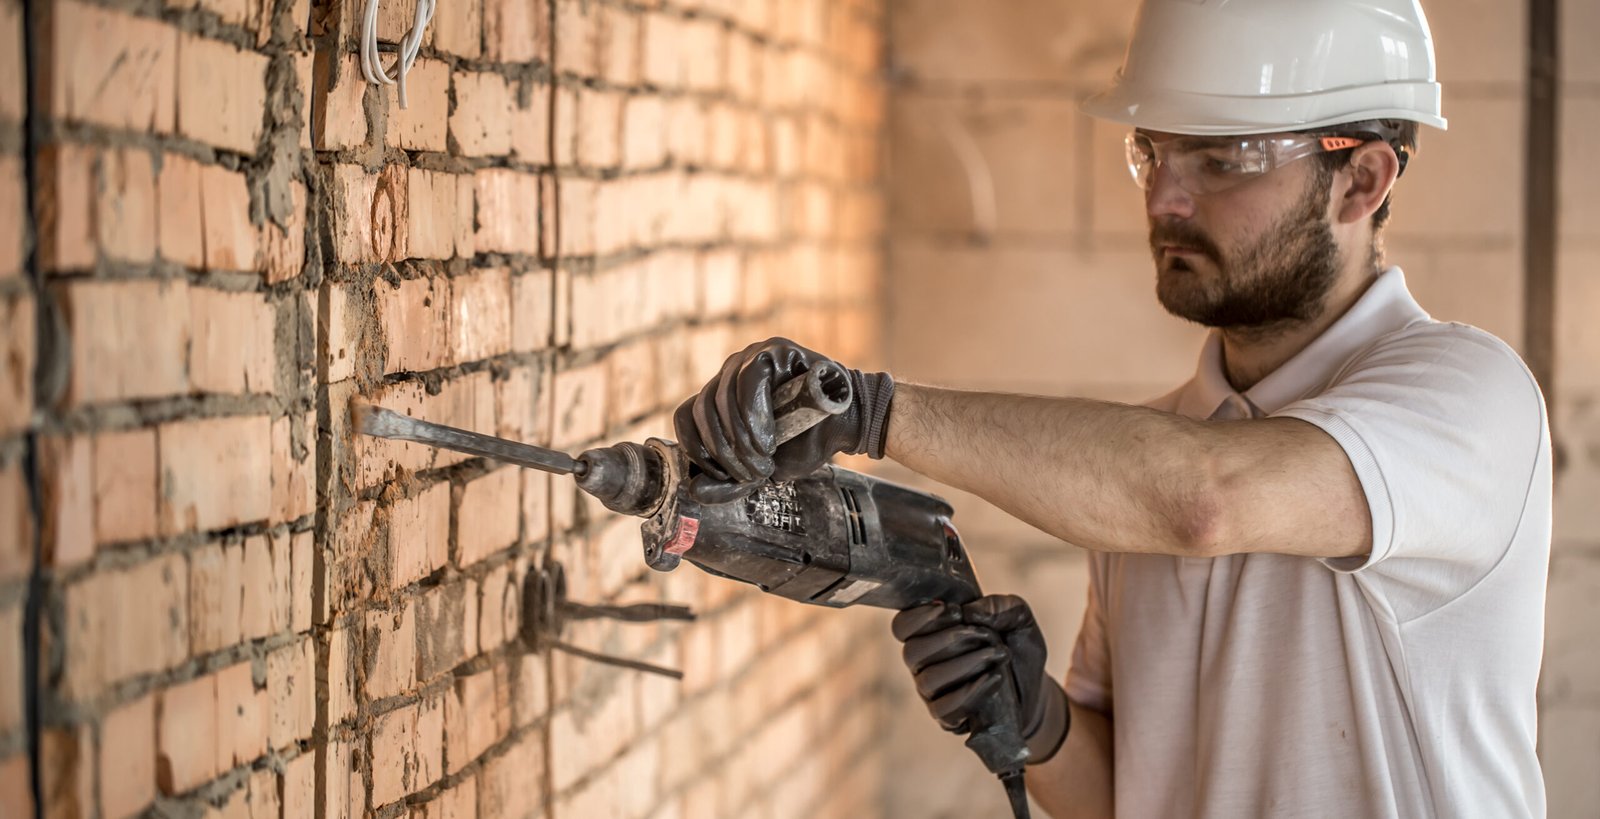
[0,0,885,819]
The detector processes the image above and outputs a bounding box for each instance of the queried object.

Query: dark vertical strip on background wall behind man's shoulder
[1523,0,1562,422]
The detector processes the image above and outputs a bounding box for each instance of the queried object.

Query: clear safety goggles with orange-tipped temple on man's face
[1123,131,1368,195]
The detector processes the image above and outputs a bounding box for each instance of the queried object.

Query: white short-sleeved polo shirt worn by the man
[1067,269,1550,819]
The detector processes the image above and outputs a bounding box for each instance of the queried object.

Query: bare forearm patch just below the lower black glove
[1027,701,1114,819]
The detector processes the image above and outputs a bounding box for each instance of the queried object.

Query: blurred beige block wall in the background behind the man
[885,0,1600,817]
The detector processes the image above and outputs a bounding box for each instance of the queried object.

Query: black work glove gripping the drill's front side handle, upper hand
[672,338,894,504]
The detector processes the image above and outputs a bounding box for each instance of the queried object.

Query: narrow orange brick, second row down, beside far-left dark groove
[38,144,96,270]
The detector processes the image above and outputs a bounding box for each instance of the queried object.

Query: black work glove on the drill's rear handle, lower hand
[893,595,1072,765]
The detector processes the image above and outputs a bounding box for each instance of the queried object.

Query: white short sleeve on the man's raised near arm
[1274,323,1547,608]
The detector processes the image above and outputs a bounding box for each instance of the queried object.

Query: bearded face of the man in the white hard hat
[1146,132,1341,330]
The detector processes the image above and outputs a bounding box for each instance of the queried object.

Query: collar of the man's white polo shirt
[1178,267,1429,417]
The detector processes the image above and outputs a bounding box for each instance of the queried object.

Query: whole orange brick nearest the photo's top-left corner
[50,0,178,134]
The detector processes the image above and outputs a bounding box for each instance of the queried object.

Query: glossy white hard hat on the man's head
[1083,0,1445,134]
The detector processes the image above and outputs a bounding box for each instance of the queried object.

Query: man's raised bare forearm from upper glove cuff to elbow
[886,384,1208,553]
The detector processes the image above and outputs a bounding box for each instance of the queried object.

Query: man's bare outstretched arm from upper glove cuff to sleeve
[886,382,1371,557]
